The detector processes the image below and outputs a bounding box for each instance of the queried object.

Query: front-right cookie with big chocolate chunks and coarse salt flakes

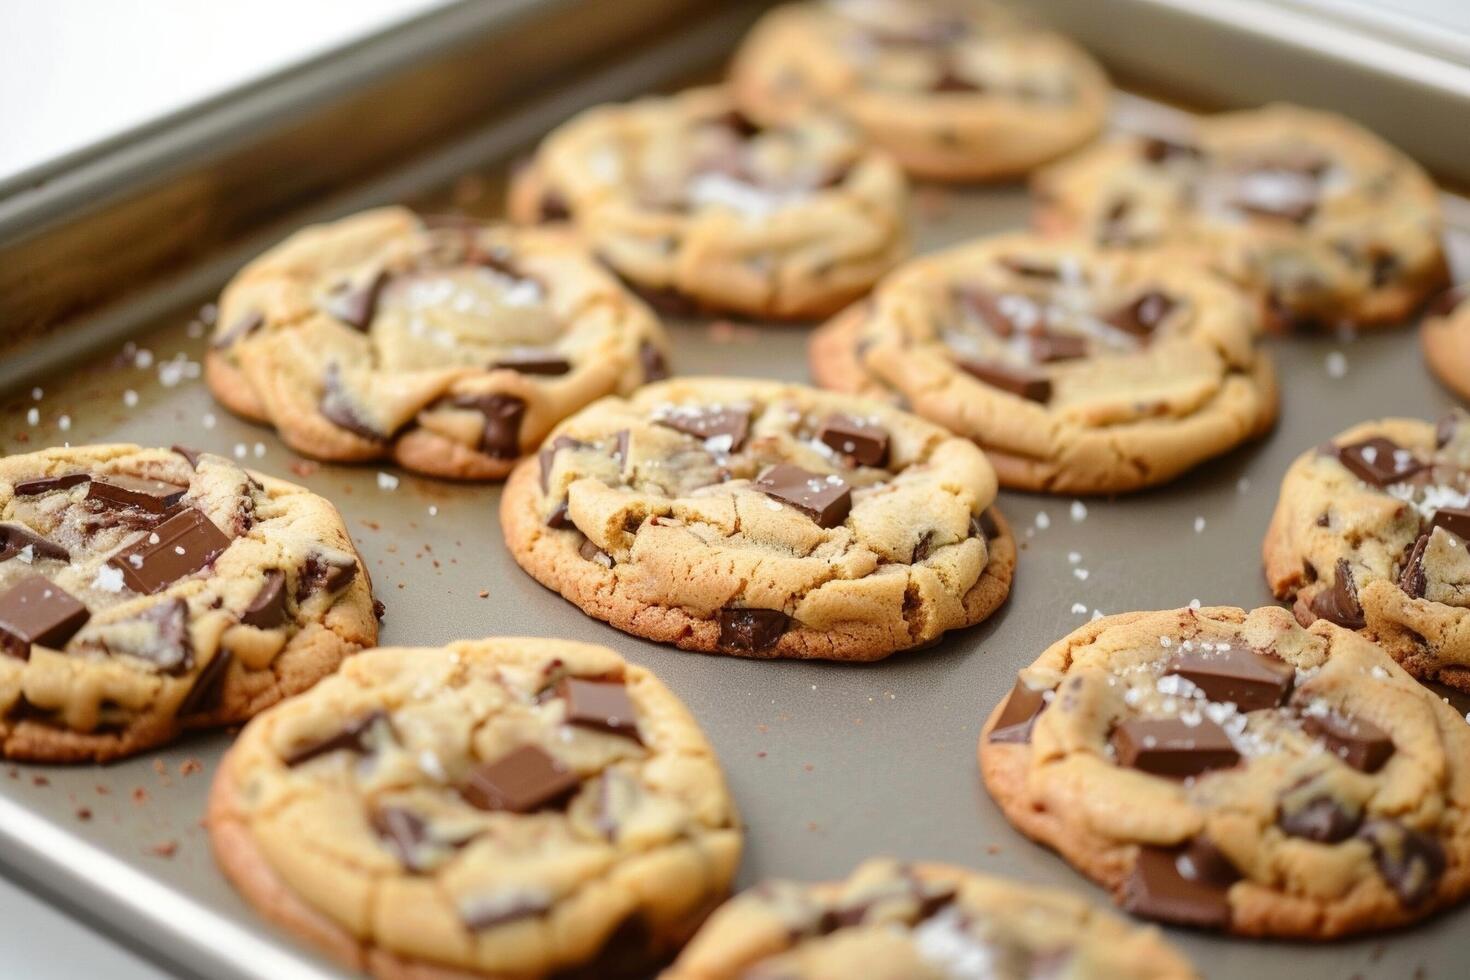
[980,607,1470,939]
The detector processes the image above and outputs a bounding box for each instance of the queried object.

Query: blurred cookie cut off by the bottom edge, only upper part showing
[663,858,1197,980]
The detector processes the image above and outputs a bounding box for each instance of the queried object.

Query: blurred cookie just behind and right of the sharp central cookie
[810,234,1277,494]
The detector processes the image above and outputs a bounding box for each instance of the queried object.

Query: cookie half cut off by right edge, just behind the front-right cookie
[1261,410,1470,691]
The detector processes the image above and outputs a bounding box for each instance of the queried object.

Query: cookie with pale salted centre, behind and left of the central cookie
[204,207,667,479]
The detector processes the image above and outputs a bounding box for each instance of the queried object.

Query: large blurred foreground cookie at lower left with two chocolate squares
[207,639,741,980]
